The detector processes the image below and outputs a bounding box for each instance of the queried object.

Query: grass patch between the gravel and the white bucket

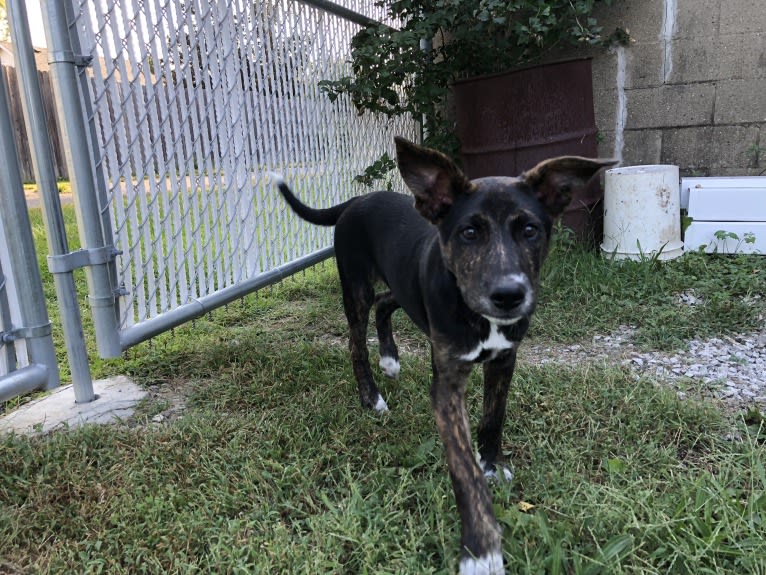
[532,228,766,349]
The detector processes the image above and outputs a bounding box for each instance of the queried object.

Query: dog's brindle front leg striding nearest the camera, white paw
[431,350,505,575]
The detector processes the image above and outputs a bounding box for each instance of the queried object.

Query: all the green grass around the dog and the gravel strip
[0,206,766,574]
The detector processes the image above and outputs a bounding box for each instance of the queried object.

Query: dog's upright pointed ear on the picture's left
[394,137,473,224]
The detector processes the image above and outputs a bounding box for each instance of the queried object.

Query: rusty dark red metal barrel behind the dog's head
[453,58,603,243]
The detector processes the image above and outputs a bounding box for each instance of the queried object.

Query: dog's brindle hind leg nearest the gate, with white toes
[338,258,388,413]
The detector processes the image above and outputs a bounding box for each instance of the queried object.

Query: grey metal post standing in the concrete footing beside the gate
[8,1,95,403]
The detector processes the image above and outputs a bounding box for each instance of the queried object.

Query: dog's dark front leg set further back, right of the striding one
[476,348,516,481]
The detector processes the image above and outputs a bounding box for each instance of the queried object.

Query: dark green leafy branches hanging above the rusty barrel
[319,0,627,166]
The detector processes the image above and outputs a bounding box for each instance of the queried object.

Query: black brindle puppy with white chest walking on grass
[276,138,615,575]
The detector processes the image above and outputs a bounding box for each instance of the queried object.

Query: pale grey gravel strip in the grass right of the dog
[519,326,766,411]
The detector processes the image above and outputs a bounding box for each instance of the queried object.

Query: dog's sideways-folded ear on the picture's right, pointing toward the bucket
[521,156,617,218]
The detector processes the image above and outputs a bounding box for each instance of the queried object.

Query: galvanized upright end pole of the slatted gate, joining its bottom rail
[40,0,121,357]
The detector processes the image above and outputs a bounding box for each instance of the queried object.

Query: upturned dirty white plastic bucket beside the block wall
[601,165,684,260]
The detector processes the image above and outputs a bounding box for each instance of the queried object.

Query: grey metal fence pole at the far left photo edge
[0,70,60,389]
